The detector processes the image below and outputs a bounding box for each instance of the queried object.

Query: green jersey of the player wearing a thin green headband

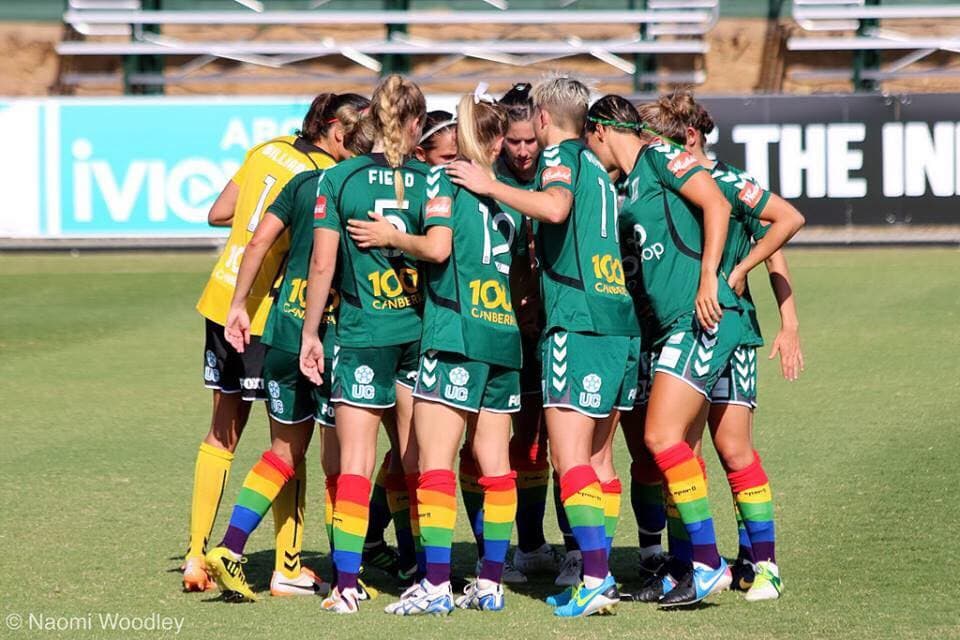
[620,142,740,345]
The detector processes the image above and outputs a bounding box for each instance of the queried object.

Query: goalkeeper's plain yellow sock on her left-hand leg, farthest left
[187,442,233,558]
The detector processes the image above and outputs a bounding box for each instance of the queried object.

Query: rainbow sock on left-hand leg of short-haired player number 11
[560,465,610,580]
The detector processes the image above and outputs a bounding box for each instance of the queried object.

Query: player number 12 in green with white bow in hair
[350,85,525,615]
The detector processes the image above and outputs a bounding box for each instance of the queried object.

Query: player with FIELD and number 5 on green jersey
[300,75,428,613]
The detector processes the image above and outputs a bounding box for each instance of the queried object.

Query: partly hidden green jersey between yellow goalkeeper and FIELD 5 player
[263,171,340,356]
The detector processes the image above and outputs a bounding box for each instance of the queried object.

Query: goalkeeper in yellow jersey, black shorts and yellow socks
[183,93,359,595]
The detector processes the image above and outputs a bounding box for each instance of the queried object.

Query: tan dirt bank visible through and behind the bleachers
[0,18,960,96]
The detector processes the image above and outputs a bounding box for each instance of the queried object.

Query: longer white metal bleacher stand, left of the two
[50,0,719,92]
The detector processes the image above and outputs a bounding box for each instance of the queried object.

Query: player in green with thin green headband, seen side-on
[586,96,741,606]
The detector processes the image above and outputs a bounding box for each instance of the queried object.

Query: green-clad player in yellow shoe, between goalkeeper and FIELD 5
[205,94,369,601]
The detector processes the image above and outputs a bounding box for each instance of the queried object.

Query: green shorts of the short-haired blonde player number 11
[540,331,640,418]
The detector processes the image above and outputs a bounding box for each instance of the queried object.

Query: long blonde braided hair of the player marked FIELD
[370,74,427,202]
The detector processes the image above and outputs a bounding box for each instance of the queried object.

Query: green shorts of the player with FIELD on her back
[331,341,420,409]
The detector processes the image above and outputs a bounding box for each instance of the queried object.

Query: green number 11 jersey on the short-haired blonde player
[536,140,640,336]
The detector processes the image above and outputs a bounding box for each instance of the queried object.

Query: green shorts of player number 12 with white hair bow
[413,351,520,413]
